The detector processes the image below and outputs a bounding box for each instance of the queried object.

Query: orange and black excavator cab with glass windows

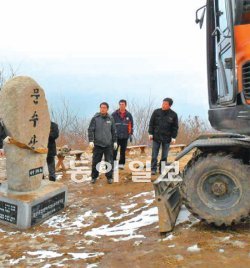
[206,0,250,135]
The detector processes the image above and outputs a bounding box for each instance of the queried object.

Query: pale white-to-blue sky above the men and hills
[0,0,208,117]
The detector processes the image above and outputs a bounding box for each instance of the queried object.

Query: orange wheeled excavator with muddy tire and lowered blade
[154,0,250,233]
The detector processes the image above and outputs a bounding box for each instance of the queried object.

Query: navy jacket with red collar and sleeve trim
[112,110,134,139]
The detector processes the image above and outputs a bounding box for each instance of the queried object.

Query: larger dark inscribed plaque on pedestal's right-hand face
[31,192,65,226]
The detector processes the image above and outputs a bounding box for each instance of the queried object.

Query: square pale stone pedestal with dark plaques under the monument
[0,180,68,229]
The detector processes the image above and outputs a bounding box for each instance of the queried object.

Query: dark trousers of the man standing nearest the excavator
[151,141,170,172]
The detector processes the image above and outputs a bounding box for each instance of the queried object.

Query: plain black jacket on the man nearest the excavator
[148,108,178,143]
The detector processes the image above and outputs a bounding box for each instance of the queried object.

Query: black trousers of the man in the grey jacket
[91,145,113,179]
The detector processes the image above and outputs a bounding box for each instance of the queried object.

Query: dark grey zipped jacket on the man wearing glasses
[88,113,117,147]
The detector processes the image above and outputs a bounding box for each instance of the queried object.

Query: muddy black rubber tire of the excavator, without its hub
[181,152,250,226]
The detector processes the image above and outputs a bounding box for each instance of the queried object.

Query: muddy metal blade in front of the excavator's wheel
[153,179,182,234]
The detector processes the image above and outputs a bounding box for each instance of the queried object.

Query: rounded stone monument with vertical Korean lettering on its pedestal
[0,76,67,229]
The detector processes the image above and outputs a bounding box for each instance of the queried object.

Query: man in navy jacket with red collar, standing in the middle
[112,100,134,169]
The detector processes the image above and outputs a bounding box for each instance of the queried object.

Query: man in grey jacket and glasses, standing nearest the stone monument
[88,102,117,184]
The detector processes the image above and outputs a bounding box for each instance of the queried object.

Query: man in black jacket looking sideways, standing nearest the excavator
[148,98,178,175]
